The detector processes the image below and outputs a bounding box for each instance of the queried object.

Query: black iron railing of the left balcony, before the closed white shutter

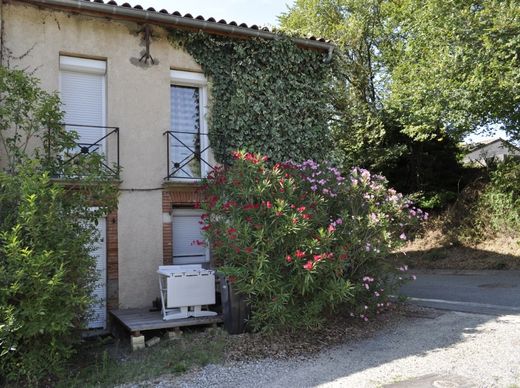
[47,123,120,178]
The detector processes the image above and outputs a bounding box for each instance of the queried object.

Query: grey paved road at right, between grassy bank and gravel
[401,270,520,315]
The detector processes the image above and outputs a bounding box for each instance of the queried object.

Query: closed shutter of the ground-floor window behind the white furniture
[172,209,209,264]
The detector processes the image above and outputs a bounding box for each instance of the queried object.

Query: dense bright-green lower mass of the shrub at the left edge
[0,163,112,383]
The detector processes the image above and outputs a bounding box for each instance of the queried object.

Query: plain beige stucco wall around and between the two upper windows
[4,1,205,308]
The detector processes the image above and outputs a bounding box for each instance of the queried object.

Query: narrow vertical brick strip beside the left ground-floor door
[106,210,119,310]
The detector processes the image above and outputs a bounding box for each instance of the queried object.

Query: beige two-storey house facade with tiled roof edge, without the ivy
[0,0,331,328]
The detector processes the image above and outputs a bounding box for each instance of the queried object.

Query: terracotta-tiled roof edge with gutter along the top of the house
[19,0,333,51]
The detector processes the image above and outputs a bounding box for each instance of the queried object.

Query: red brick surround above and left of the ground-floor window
[162,186,201,265]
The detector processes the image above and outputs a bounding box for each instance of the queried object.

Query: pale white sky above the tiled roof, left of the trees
[134,0,294,27]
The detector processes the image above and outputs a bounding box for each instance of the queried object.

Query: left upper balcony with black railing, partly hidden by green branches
[47,124,120,179]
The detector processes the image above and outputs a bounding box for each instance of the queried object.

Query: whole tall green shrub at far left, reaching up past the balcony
[0,68,117,385]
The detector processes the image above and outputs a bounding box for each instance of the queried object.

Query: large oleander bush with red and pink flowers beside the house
[201,152,426,330]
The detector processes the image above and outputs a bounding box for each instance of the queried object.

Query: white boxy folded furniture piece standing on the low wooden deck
[157,264,217,321]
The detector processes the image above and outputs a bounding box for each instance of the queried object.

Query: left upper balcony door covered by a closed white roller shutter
[60,56,106,154]
